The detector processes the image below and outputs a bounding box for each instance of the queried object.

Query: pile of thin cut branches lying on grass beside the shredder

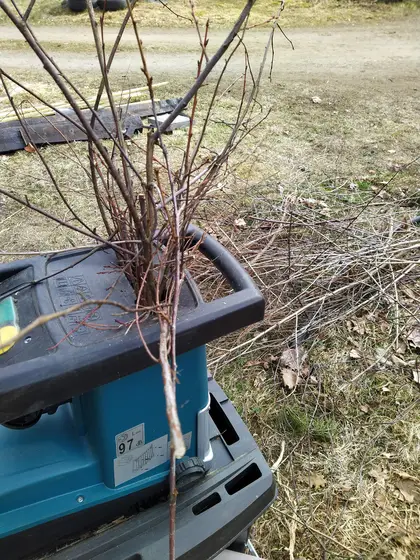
[196,182,420,366]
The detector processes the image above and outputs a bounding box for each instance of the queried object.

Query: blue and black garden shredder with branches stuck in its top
[0,226,276,560]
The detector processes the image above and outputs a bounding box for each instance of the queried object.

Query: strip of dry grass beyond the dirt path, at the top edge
[0,0,418,28]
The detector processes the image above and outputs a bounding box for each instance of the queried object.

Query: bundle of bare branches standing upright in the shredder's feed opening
[0,0,282,558]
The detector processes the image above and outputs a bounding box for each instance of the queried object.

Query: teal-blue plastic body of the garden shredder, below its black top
[0,347,208,538]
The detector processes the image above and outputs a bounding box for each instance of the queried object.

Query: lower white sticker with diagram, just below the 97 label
[114,434,169,486]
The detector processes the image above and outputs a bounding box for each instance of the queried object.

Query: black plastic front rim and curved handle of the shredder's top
[0,226,265,422]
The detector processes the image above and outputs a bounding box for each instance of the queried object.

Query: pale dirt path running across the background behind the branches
[0,18,420,89]
